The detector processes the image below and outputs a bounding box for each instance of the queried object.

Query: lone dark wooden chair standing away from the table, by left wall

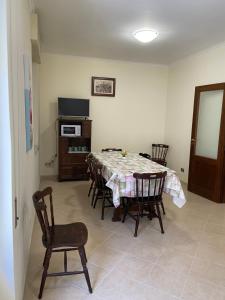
[33,187,92,299]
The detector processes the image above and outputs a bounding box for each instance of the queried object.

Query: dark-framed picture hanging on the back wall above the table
[91,76,116,97]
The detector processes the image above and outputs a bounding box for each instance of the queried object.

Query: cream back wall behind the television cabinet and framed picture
[40,54,168,175]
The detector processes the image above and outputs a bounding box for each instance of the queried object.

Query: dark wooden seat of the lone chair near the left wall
[43,222,88,248]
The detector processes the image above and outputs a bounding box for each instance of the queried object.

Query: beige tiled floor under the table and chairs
[24,182,225,300]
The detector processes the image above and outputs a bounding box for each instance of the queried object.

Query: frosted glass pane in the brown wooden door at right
[195,90,223,159]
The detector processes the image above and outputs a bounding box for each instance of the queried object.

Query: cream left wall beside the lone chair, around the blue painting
[8,0,39,300]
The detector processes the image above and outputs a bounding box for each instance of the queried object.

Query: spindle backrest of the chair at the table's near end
[133,172,167,202]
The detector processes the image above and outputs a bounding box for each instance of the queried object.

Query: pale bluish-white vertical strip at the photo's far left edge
[0,0,15,300]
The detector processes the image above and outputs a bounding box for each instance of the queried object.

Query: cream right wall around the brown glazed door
[165,44,225,182]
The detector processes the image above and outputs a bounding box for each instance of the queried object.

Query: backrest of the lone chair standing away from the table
[33,187,55,245]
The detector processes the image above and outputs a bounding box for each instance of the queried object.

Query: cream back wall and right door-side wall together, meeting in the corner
[40,44,225,182]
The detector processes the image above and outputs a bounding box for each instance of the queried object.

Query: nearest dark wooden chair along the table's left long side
[92,160,114,220]
